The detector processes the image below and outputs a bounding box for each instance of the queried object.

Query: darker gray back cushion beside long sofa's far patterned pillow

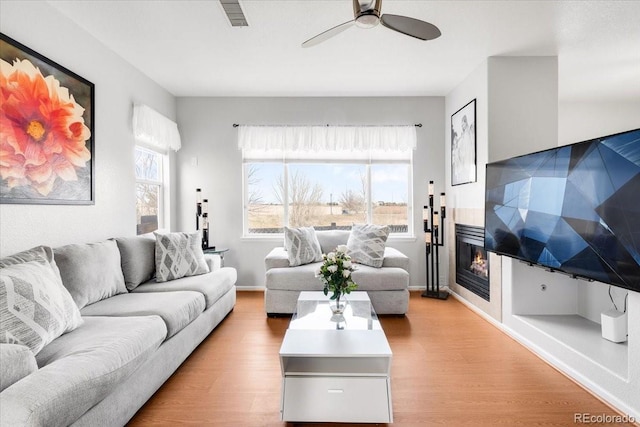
[115,233,156,290]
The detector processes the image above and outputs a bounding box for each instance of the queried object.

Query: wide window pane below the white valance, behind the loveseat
[244,161,412,235]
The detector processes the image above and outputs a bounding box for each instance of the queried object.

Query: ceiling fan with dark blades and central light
[302,0,441,47]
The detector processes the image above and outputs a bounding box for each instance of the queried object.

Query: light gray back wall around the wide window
[178,97,446,288]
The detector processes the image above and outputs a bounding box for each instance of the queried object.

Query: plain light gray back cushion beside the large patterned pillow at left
[53,240,127,309]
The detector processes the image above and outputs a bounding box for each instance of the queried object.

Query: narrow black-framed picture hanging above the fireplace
[451,99,477,185]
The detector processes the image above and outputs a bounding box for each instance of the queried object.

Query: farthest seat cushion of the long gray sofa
[131,267,238,310]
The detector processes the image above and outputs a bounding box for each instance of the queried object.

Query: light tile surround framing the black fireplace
[445,208,502,321]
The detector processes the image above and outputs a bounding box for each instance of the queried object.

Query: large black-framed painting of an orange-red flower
[0,33,94,204]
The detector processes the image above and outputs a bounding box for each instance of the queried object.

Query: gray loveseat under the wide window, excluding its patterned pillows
[264,230,409,315]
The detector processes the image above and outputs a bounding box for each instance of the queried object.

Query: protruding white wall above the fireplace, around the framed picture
[445,57,558,209]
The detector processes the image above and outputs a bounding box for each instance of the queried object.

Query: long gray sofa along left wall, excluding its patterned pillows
[0,236,237,427]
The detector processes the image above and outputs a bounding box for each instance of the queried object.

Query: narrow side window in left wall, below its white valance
[135,147,166,234]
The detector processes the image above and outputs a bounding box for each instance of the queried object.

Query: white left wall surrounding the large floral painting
[0,0,175,256]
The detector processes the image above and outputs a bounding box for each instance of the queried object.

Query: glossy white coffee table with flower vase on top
[280,292,393,423]
